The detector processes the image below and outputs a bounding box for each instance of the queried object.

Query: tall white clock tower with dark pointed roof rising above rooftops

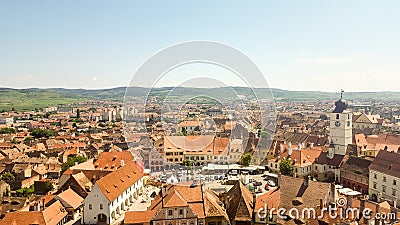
[327,90,353,159]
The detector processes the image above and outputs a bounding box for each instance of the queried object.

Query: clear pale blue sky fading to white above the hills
[0,0,400,92]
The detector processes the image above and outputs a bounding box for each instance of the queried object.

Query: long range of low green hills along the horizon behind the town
[0,87,400,111]
